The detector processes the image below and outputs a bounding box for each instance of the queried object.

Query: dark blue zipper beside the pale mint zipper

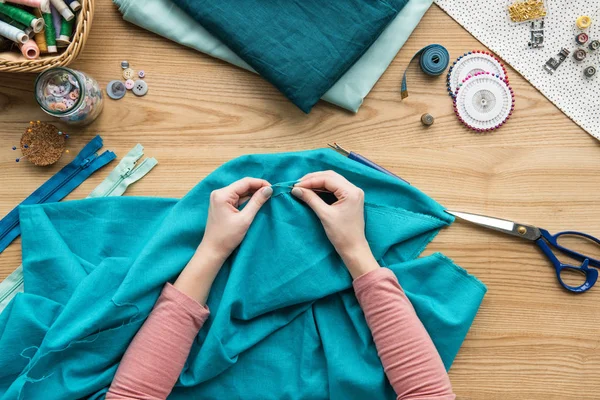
[0,136,116,253]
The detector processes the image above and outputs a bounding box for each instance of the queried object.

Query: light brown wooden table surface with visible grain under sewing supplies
[0,0,600,400]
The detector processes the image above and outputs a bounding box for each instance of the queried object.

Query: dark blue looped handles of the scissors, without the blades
[536,229,600,293]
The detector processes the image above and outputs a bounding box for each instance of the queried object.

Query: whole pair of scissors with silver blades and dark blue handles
[446,210,600,293]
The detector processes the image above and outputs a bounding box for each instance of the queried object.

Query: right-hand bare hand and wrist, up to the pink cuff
[292,171,379,279]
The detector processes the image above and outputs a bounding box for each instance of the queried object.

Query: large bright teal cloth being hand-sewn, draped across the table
[0,149,486,400]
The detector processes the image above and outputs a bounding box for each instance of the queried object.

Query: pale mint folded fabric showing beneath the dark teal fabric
[113,0,433,112]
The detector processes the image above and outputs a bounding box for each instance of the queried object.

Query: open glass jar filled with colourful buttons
[34,67,103,125]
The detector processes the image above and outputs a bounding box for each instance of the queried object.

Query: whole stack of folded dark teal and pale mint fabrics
[113,0,432,113]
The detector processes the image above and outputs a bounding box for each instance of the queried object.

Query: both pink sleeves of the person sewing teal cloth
[106,268,455,400]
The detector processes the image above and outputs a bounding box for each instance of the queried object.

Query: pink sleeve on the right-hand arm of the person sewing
[353,268,456,400]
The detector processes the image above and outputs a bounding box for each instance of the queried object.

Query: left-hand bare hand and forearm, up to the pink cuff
[175,178,273,304]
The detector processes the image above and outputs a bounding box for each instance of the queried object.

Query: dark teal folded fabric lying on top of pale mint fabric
[173,0,408,113]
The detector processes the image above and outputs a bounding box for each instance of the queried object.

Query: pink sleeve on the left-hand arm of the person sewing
[106,283,209,400]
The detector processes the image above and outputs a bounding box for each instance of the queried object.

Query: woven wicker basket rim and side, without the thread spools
[0,0,94,72]
